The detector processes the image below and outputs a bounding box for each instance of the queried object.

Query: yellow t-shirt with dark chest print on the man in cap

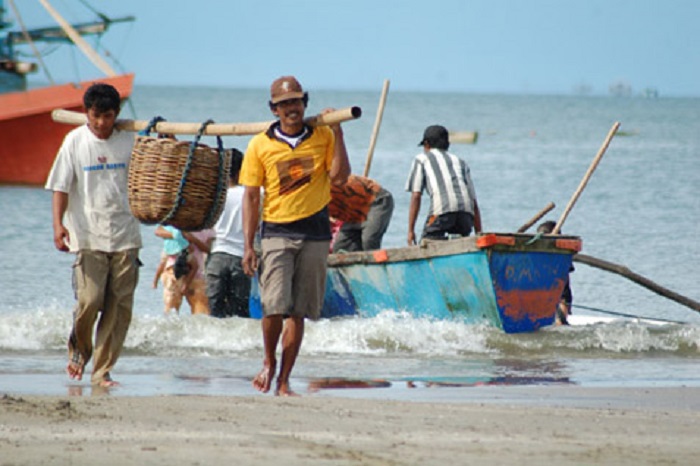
[239,125,335,223]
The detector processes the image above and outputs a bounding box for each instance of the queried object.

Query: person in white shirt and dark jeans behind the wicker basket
[206,149,251,317]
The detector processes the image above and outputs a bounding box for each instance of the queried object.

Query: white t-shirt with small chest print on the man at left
[46,125,141,252]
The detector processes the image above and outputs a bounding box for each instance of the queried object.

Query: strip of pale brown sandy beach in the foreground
[0,387,700,466]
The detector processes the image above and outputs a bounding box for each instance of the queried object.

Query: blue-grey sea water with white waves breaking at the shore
[0,86,700,398]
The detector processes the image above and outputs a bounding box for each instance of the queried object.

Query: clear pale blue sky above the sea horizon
[6,0,700,96]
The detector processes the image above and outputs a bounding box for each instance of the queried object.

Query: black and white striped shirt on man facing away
[406,149,476,216]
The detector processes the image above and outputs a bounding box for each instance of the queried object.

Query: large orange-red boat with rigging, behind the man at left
[0,0,134,186]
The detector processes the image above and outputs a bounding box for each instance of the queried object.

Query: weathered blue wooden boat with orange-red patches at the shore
[250,233,582,333]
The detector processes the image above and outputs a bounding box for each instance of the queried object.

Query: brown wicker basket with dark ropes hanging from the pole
[129,119,231,231]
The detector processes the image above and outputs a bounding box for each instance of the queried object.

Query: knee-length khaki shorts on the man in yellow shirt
[260,237,330,319]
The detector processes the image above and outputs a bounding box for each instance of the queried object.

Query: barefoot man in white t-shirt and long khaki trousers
[46,83,142,387]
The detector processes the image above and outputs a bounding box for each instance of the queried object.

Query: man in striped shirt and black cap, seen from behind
[406,125,481,246]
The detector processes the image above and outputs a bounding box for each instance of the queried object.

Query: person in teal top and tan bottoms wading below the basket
[153,225,214,315]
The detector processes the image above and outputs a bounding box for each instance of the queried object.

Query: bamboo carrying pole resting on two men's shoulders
[51,107,362,136]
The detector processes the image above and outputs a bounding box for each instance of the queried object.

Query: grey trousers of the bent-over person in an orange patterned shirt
[333,179,394,252]
